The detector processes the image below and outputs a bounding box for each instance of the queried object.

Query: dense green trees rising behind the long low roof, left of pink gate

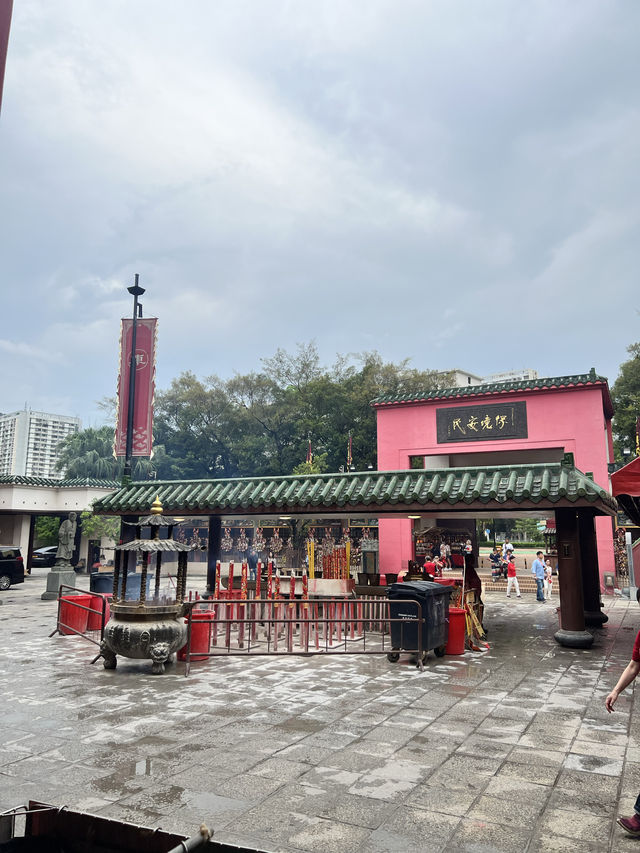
[59,343,441,480]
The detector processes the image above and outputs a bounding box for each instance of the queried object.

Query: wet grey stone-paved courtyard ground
[0,573,640,853]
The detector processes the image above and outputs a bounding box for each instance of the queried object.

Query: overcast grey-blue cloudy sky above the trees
[0,0,640,426]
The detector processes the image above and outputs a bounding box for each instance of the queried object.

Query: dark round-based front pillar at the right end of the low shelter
[555,508,593,649]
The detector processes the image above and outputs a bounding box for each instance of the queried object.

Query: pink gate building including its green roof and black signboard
[373,369,615,588]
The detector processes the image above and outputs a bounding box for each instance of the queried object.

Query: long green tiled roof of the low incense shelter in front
[94,462,616,515]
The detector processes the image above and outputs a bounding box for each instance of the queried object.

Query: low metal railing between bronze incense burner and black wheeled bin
[180,597,427,675]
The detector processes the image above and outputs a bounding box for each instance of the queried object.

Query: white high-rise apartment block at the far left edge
[0,410,82,480]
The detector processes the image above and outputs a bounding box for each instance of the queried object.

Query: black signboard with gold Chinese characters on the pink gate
[436,402,528,444]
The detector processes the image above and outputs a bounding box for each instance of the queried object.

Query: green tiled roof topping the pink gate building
[371,368,613,416]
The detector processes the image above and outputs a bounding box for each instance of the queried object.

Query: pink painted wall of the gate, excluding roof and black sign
[377,386,614,579]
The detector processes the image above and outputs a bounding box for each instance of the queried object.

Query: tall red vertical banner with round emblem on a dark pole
[114,317,158,456]
